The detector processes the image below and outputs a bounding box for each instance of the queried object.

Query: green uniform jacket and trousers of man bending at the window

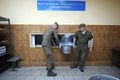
[42,28,59,69]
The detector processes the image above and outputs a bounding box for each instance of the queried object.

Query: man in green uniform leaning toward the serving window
[42,22,59,76]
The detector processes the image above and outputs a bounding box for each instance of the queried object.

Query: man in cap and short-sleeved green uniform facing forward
[71,24,93,72]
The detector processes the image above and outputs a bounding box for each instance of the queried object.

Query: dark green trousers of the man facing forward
[74,48,87,68]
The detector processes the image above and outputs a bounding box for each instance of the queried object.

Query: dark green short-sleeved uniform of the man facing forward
[74,31,93,67]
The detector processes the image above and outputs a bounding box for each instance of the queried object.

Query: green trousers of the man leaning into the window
[42,47,53,69]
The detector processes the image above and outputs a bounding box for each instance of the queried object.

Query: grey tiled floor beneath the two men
[0,66,120,80]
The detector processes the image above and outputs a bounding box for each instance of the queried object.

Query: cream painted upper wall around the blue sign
[0,0,120,25]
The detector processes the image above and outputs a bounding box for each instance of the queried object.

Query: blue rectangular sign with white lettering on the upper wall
[37,0,86,11]
